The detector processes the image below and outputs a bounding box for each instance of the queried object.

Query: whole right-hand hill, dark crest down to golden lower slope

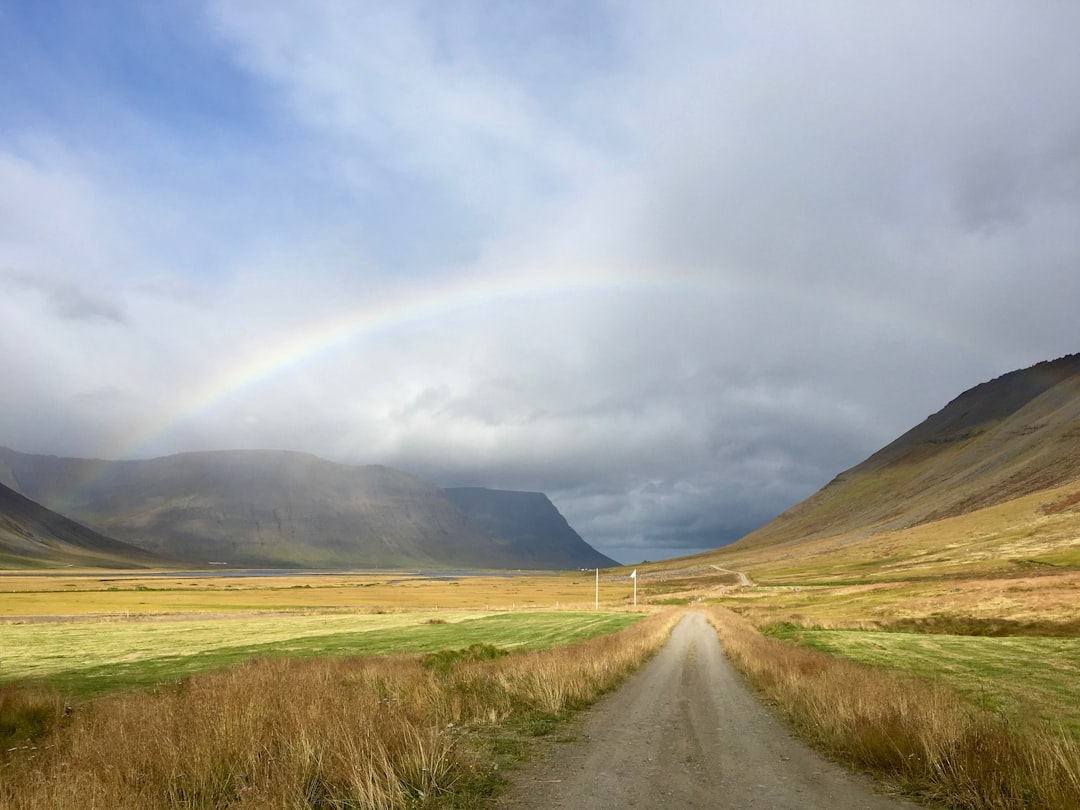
[643,354,1080,591]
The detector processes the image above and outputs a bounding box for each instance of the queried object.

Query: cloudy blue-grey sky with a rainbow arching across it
[0,0,1080,563]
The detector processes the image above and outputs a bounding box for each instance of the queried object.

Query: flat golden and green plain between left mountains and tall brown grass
[0,572,639,694]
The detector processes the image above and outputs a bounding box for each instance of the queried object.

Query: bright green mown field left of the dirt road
[0,611,640,696]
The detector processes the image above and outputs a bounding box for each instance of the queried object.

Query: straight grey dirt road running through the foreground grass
[497,613,916,810]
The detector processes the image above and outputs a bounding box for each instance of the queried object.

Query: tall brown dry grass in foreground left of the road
[0,615,674,810]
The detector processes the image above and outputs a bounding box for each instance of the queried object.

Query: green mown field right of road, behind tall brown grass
[772,626,1080,739]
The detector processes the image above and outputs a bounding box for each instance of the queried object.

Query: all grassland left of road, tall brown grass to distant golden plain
[0,572,677,810]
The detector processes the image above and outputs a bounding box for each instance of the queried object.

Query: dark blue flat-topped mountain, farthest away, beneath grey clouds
[443,487,619,568]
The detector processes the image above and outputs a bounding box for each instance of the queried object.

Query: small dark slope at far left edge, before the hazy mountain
[0,484,167,568]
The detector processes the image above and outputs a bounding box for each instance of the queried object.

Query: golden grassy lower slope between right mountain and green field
[622,483,1080,634]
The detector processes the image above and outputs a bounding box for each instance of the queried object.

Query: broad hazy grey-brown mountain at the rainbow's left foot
[0,448,609,568]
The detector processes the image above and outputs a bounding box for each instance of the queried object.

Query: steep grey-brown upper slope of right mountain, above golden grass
[728,354,1080,551]
